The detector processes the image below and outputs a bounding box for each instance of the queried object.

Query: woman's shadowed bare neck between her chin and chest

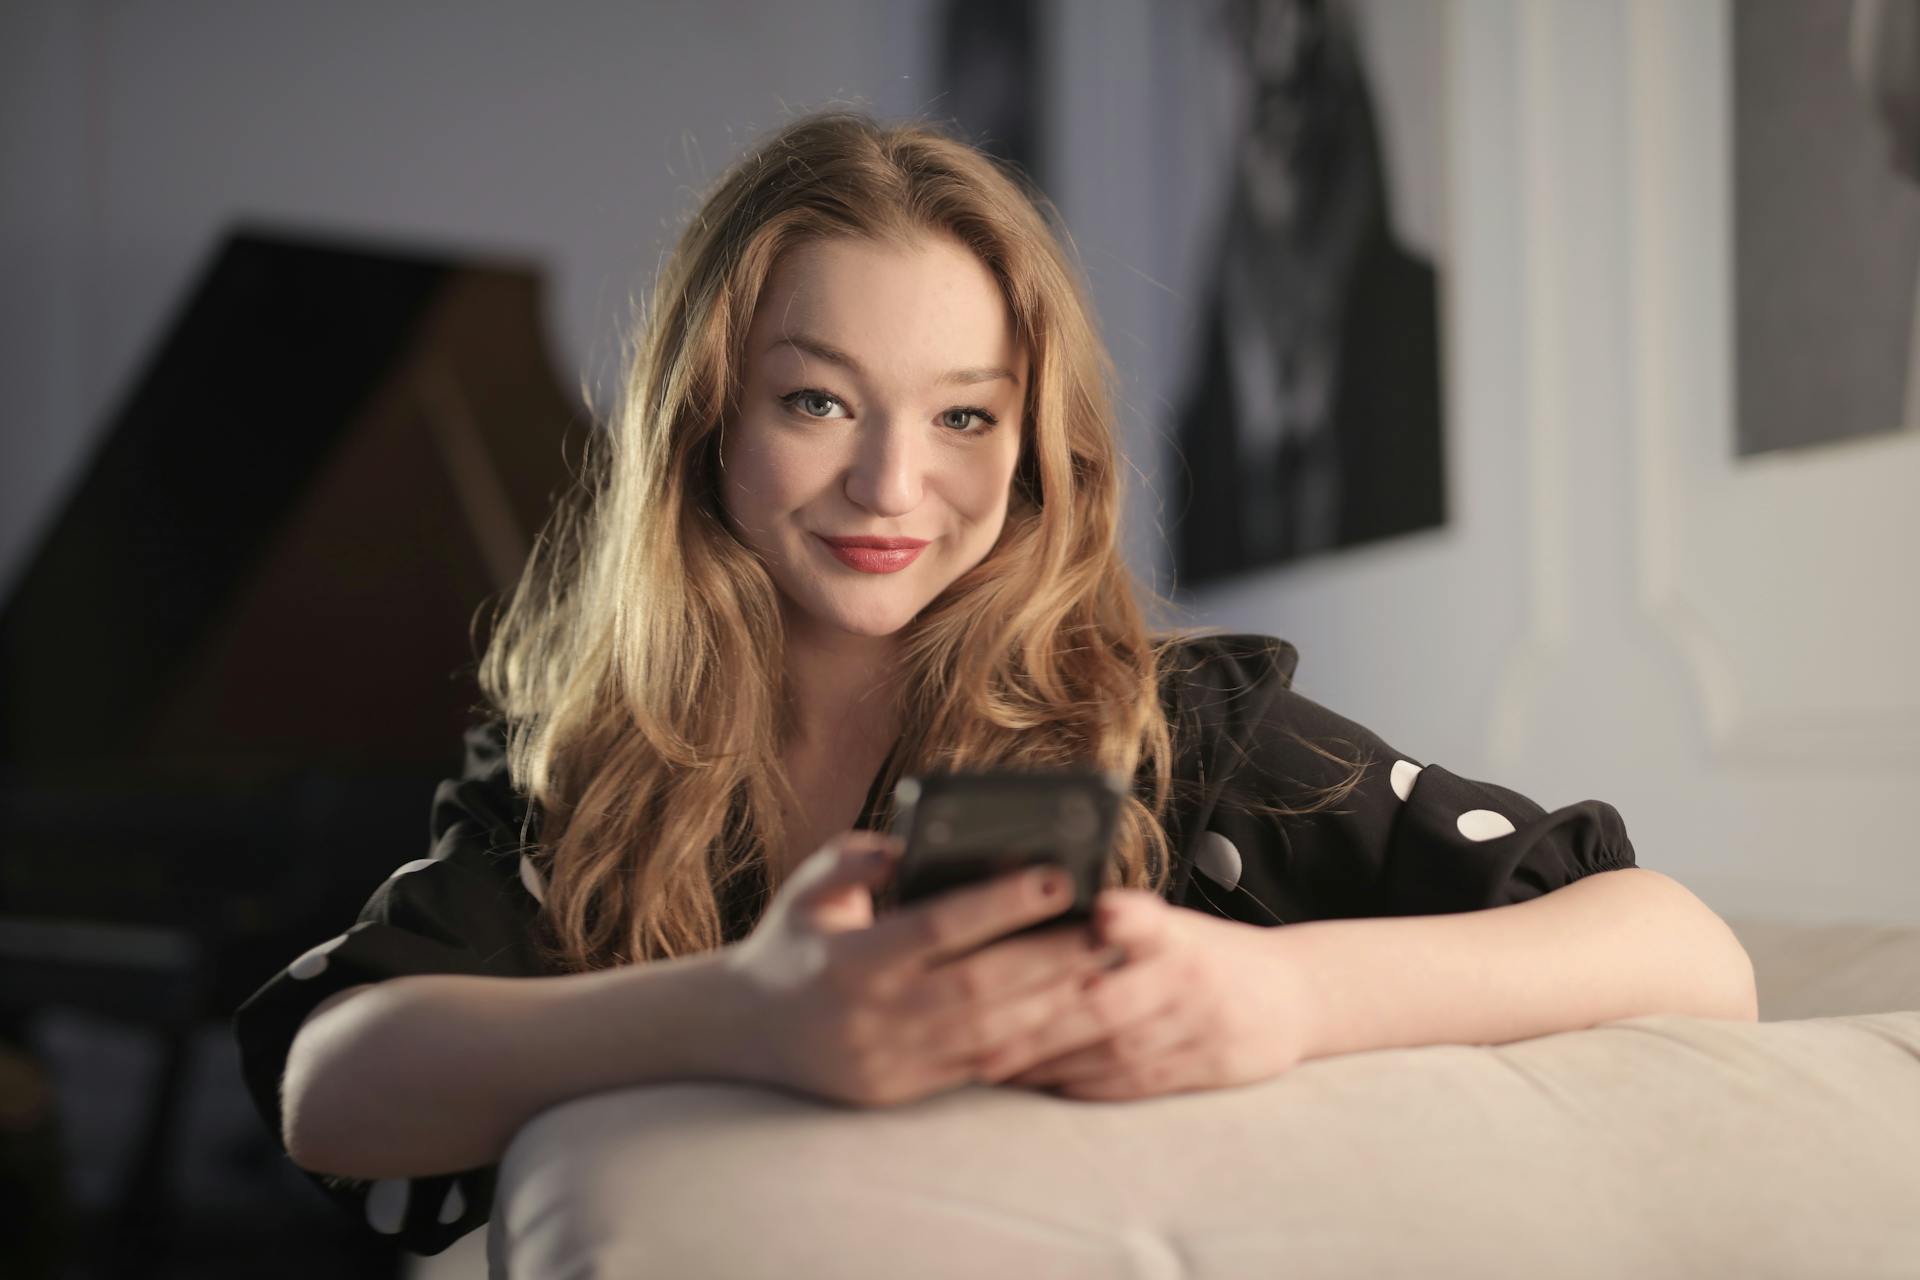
[785,610,900,752]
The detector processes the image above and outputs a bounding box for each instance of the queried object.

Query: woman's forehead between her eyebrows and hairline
[749,236,1023,374]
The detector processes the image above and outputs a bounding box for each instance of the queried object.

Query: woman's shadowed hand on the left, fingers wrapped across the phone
[724,831,1112,1107]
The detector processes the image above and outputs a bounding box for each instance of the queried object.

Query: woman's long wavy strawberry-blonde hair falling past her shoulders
[480,111,1357,971]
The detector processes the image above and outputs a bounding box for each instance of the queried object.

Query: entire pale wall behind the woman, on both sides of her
[0,0,1920,932]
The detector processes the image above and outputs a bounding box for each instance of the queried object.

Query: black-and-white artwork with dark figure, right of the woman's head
[1165,0,1448,589]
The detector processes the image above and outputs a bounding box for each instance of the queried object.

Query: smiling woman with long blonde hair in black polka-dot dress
[236,113,1751,1253]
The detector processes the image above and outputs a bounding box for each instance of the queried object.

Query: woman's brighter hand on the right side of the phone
[981,889,1311,1100]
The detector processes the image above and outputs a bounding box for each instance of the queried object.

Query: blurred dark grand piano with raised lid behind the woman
[0,230,591,1274]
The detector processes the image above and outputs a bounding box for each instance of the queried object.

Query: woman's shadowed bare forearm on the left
[284,952,739,1178]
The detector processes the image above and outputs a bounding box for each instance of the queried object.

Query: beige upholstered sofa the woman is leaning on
[417,921,1920,1280]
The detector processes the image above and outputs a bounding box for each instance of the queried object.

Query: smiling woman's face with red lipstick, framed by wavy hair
[720,236,1027,635]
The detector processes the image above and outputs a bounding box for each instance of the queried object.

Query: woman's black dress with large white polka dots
[234,635,1634,1253]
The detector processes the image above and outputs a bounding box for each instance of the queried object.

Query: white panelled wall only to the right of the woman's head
[1056,0,1920,919]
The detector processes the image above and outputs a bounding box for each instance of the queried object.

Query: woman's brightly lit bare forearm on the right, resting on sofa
[1269,867,1757,1057]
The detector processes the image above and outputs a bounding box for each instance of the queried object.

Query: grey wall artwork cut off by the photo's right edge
[1730,0,1920,457]
